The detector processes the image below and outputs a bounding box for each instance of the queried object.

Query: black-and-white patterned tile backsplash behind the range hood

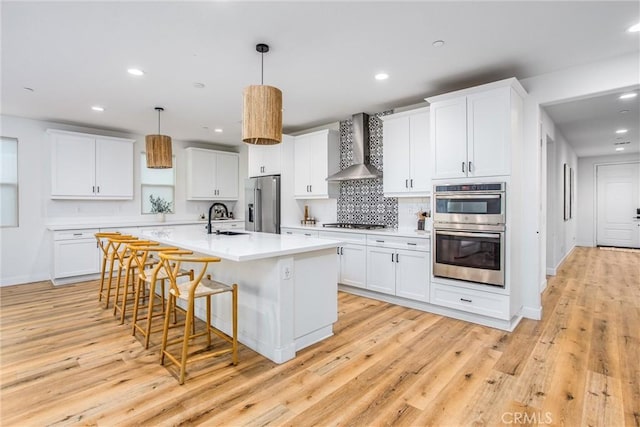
[337,110,398,228]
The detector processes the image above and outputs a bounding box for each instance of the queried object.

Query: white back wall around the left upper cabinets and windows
[0,116,240,286]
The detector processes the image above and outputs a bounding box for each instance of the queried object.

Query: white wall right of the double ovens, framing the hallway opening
[521,53,640,319]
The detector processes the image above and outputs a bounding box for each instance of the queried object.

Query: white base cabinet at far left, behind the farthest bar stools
[53,229,100,279]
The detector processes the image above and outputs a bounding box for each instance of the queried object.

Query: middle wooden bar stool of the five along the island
[113,238,160,325]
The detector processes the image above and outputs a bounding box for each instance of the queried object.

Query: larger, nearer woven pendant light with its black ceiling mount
[242,43,282,145]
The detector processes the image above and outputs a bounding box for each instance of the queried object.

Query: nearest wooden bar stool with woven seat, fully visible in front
[159,252,238,384]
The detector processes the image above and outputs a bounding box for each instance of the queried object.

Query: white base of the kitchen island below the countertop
[174,249,338,363]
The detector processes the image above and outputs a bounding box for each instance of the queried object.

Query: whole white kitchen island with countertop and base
[137,227,340,363]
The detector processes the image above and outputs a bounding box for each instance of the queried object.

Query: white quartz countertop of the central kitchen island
[133,227,341,261]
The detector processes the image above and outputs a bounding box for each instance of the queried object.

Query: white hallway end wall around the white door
[576,153,640,246]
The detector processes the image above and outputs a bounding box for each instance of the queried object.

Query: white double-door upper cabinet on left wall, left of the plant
[47,129,135,200]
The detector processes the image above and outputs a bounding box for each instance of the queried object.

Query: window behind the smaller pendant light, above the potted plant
[140,153,176,214]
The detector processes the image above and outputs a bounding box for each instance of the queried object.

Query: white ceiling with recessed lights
[1,0,640,157]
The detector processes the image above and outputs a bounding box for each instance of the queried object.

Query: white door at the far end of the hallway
[596,163,640,248]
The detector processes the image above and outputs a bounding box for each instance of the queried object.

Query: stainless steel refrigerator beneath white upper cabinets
[244,175,280,234]
